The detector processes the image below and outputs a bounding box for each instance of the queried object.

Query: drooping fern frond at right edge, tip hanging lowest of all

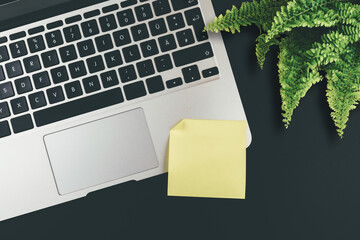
[326,45,360,137]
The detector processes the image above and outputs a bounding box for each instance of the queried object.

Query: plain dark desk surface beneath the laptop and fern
[0,0,360,240]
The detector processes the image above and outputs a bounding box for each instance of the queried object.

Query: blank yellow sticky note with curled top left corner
[168,119,246,199]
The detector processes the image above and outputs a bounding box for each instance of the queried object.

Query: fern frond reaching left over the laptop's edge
[204,0,288,33]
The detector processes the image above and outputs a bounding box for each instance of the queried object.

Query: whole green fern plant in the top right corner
[204,0,360,137]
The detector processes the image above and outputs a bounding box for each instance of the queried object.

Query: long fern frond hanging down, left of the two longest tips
[278,33,322,128]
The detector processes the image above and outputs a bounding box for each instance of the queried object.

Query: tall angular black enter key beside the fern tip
[185,8,209,42]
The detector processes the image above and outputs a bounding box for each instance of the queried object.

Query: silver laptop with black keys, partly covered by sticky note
[0,0,251,220]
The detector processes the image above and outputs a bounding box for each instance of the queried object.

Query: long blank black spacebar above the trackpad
[34,88,124,127]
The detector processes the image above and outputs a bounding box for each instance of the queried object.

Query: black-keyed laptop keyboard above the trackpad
[0,0,219,138]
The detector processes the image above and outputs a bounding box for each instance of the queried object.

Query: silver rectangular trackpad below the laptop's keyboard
[44,108,158,195]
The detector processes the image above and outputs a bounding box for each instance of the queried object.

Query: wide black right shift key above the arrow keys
[172,42,214,67]
